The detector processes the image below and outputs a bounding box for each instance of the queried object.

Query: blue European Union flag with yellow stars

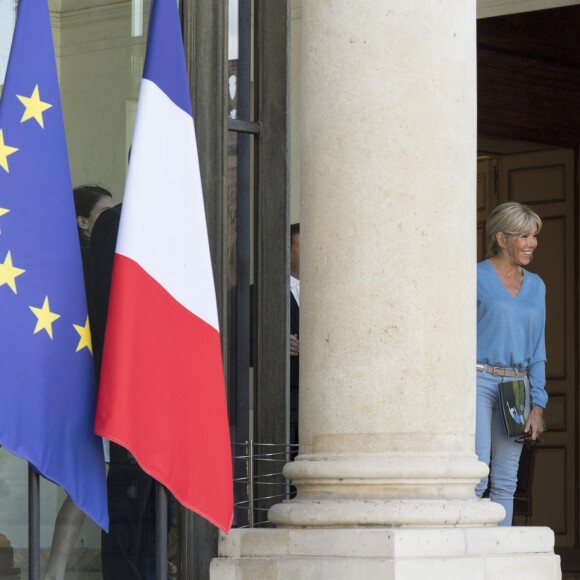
[0,0,108,529]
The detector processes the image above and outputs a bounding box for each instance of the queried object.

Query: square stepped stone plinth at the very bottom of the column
[210,527,562,580]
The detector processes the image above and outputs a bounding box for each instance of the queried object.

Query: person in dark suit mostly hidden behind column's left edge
[290,223,300,445]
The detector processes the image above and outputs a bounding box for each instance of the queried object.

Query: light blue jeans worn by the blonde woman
[475,372,527,526]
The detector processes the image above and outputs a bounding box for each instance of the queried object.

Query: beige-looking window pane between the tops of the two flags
[61,0,150,201]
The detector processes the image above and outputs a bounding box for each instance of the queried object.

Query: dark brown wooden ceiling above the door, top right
[477,4,580,154]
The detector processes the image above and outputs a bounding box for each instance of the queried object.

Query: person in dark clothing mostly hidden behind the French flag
[89,204,156,580]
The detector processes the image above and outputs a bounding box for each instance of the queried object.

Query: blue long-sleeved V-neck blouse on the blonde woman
[477,260,548,407]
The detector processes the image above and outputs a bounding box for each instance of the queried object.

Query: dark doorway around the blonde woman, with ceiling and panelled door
[477,6,580,570]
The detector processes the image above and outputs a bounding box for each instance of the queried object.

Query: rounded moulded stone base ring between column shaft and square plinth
[268,446,498,528]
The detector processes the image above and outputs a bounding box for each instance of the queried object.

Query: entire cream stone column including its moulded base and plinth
[211,0,560,580]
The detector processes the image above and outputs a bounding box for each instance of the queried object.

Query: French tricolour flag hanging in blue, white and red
[95,0,233,532]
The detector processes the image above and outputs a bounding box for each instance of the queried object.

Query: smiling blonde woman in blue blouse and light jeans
[475,202,548,526]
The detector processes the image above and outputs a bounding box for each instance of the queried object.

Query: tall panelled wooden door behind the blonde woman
[498,150,578,548]
